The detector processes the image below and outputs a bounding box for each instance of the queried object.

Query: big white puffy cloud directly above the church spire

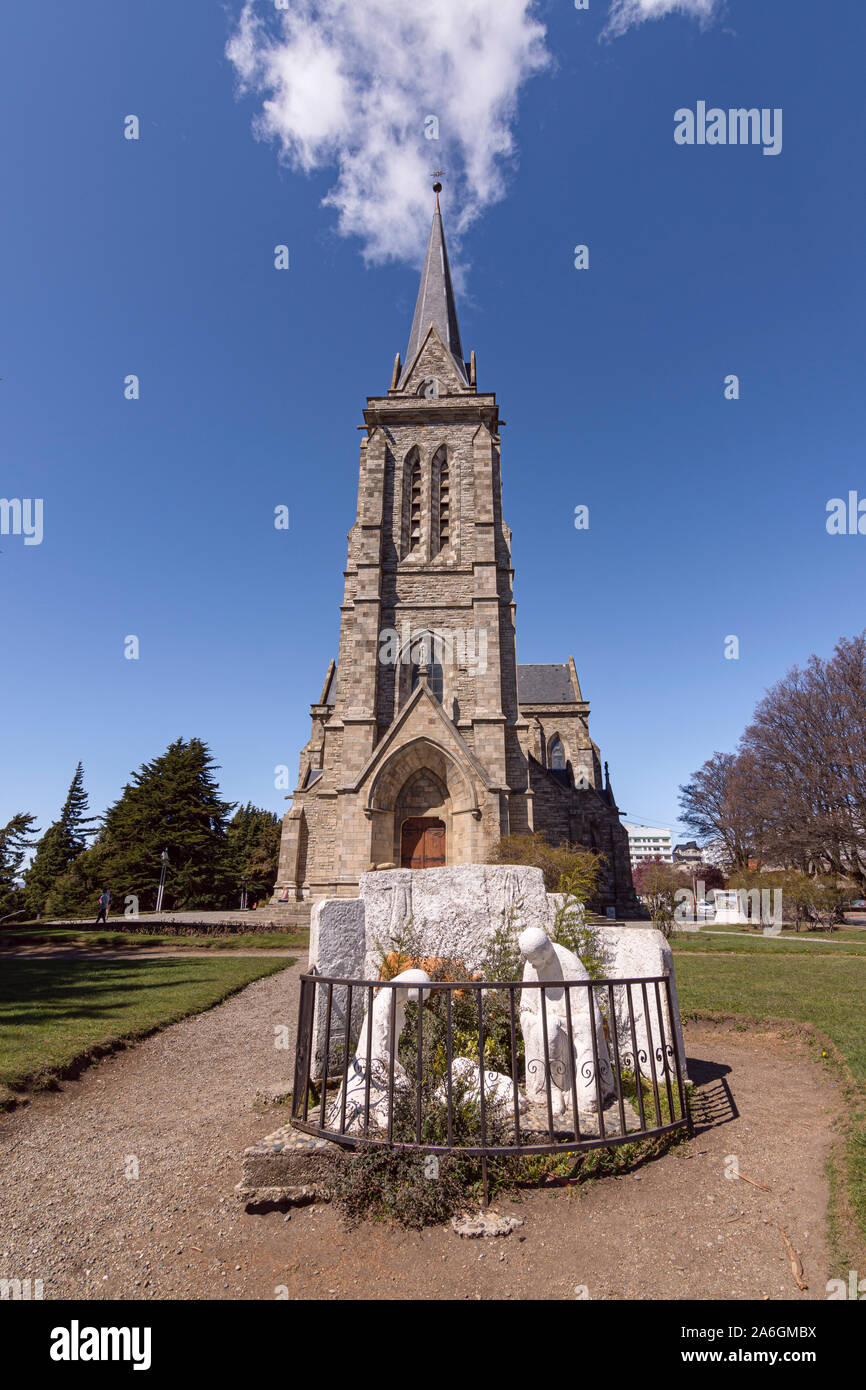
[227,0,549,261]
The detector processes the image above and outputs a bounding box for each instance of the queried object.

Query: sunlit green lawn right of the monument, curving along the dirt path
[674,937,866,1268]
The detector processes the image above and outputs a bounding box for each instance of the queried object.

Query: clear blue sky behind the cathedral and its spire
[0,0,866,845]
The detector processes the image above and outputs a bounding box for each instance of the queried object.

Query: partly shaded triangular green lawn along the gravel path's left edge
[0,958,291,1108]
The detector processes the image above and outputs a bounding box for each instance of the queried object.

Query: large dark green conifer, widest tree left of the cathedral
[46,738,235,915]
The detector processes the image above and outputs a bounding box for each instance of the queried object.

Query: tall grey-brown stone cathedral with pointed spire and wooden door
[272,185,637,923]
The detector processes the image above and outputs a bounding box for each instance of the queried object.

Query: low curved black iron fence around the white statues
[292,970,691,1166]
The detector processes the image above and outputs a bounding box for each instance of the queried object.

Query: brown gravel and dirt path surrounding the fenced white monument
[0,952,838,1300]
